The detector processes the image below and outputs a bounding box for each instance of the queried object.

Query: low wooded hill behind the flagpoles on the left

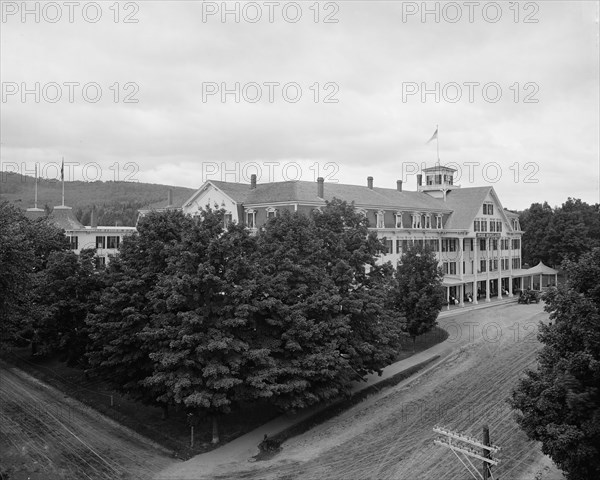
[0,172,195,226]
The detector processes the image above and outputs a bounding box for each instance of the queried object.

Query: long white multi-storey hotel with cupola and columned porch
[140,165,541,306]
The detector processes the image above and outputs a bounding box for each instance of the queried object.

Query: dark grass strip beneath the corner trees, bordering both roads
[3,327,448,459]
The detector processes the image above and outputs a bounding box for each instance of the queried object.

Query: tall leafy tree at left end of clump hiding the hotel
[87,211,193,415]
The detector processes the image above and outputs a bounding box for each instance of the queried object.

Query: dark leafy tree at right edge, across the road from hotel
[510,248,600,480]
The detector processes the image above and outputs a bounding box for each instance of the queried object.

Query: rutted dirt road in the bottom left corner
[0,364,173,480]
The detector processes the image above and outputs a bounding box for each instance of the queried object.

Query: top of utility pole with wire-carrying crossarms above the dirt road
[433,425,500,480]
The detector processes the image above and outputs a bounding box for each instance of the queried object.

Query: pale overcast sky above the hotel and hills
[0,0,600,209]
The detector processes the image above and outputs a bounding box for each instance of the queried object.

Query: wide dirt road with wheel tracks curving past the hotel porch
[157,304,560,480]
